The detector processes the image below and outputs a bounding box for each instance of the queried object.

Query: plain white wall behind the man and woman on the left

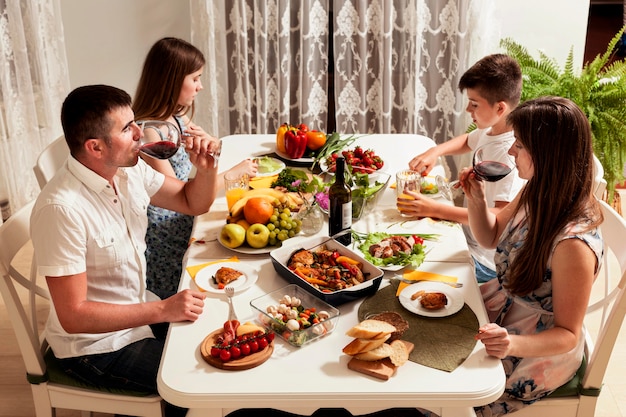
[60,0,191,95]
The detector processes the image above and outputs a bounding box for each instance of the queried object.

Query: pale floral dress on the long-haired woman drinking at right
[476,214,603,417]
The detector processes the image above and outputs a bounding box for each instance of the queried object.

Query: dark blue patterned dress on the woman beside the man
[146,117,194,299]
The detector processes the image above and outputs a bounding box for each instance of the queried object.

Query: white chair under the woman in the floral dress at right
[513,201,626,417]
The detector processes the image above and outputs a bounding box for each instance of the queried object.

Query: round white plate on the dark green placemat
[398,281,465,317]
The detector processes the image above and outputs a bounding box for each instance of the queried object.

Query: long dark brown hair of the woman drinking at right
[507,97,602,295]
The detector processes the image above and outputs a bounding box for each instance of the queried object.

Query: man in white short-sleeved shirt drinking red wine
[31,85,219,414]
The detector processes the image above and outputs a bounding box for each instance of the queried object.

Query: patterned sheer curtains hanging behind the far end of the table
[191,0,498,171]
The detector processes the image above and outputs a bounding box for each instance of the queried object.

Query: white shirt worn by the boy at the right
[463,128,526,271]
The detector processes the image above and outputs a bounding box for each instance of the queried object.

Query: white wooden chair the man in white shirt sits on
[0,202,162,417]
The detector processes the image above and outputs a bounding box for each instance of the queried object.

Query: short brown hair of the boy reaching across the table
[459,54,522,108]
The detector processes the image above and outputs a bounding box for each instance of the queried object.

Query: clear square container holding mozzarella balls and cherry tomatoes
[250,284,339,347]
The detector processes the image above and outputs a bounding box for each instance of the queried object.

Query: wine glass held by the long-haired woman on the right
[435,140,515,201]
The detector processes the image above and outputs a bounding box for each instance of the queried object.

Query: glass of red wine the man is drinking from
[137,120,222,167]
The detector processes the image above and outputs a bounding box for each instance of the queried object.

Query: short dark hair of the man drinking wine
[61,85,132,155]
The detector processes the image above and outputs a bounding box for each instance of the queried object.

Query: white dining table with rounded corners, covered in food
[157,134,505,417]
